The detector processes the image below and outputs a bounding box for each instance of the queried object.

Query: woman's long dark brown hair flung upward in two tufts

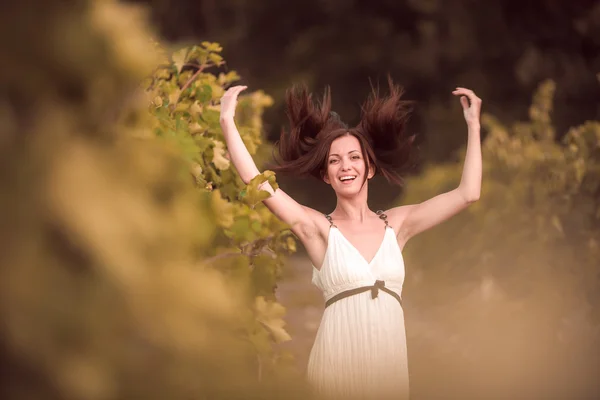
[273,78,414,184]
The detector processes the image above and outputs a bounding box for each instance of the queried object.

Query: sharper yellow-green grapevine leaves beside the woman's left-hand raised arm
[147,42,295,374]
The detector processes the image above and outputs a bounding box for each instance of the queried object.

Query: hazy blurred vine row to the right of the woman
[402,81,600,399]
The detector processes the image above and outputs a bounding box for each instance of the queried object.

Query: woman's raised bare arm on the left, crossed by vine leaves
[220,86,322,242]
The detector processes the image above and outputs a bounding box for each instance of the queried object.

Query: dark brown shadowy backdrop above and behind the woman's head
[129,0,600,211]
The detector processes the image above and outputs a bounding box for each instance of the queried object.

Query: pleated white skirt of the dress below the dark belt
[307,292,409,400]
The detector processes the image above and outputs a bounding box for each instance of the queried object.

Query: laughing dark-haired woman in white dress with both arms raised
[221,81,481,399]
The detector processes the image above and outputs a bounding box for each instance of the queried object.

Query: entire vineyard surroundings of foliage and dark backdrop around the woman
[0,0,600,400]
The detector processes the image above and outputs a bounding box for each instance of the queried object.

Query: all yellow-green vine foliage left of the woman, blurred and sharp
[0,0,307,400]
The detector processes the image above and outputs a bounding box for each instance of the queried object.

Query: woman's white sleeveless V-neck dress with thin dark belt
[307,214,408,400]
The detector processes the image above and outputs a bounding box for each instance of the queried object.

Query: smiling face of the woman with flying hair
[324,135,373,196]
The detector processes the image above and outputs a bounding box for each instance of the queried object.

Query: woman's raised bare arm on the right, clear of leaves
[389,88,482,242]
